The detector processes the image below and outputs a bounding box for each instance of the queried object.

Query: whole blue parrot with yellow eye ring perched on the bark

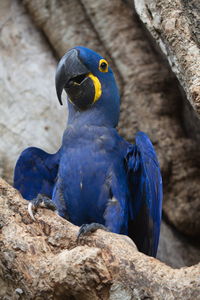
[14,46,162,257]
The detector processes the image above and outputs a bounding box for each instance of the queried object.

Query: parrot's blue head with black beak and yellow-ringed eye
[56,46,120,127]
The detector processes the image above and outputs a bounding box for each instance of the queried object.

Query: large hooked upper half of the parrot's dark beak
[56,49,89,105]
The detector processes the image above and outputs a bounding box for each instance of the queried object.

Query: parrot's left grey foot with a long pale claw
[28,194,57,221]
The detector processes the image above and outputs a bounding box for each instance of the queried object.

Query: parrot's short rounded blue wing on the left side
[14,147,60,200]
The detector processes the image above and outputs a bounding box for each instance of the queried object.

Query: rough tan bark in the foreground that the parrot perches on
[0,180,200,300]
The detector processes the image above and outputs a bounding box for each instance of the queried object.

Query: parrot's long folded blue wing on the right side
[126,132,162,257]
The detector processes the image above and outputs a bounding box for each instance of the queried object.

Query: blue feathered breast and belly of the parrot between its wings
[59,128,122,225]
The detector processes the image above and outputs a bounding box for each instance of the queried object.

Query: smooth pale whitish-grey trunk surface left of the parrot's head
[0,0,66,182]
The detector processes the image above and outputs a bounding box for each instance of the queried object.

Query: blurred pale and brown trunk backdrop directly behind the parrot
[0,0,200,268]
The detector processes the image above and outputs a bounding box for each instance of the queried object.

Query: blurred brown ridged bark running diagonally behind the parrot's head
[21,0,200,236]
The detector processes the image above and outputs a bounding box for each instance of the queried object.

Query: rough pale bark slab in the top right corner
[134,0,200,114]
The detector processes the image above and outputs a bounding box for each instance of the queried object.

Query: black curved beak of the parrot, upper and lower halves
[56,49,95,109]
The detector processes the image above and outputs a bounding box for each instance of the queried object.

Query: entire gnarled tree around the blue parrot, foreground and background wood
[0,0,200,300]
